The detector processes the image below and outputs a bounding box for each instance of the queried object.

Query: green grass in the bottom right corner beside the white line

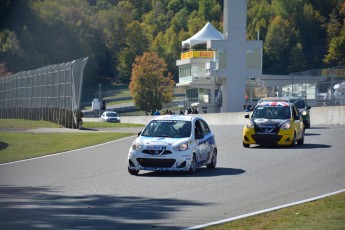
[205,192,345,230]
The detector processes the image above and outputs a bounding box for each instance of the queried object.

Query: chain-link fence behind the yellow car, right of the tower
[246,66,345,106]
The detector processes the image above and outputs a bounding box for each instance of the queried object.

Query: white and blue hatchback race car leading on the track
[128,115,217,175]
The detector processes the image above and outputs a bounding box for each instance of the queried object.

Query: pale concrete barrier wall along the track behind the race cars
[84,106,345,126]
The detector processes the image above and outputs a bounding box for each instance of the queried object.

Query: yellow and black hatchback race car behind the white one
[242,101,304,148]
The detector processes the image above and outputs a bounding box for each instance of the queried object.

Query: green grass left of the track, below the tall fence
[0,119,143,163]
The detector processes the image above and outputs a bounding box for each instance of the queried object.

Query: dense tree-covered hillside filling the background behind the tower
[0,0,345,86]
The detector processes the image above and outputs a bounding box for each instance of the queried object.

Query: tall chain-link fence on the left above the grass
[0,58,88,128]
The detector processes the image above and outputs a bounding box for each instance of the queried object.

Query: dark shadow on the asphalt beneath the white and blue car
[137,167,246,177]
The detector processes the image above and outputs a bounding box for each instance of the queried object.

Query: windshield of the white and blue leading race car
[141,120,191,138]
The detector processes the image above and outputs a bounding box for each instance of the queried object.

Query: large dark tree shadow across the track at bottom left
[0,186,204,230]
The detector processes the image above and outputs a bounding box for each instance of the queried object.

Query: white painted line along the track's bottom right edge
[183,189,345,230]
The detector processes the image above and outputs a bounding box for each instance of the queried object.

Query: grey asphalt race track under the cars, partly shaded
[0,125,345,230]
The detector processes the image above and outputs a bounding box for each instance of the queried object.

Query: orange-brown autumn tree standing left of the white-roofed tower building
[129,52,175,113]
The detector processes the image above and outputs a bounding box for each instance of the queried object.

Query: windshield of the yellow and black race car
[252,106,291,119]
